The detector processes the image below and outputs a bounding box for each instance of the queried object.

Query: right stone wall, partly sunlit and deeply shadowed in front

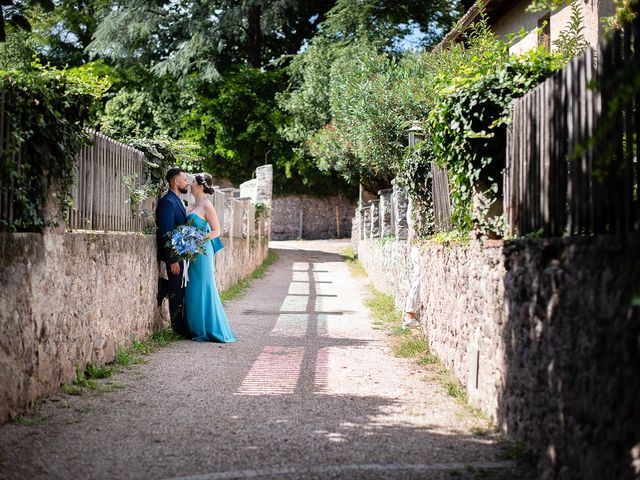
[358,237,640,480]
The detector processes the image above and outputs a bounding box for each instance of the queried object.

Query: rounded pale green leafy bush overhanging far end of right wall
[296,40,424,191]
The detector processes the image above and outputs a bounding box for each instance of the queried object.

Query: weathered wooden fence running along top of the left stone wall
[0,117,270,238]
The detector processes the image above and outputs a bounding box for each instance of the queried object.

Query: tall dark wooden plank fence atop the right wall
[504,20,640,236]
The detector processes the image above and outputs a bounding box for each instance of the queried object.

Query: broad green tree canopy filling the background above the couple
[0,0,461,197]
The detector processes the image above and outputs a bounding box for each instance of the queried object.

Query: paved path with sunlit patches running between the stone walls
[0,241,521,480]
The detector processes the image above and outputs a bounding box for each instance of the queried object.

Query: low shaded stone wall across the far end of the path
[271,195,355,240]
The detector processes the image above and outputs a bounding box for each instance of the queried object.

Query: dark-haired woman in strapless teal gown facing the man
[184,173,236,343]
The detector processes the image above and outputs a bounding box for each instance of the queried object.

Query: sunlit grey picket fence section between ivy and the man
[67,130,150,232]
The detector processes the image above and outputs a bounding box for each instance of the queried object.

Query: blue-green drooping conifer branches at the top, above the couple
[90,0,333,78]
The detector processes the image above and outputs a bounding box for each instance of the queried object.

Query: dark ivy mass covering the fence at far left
[0,63,108,231]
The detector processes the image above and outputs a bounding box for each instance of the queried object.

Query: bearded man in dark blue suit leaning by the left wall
[156,168,189,337]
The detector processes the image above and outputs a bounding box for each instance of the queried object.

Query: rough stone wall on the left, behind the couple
[0,233,268,424]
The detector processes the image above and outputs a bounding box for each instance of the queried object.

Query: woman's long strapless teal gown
[184,213,236,343]
